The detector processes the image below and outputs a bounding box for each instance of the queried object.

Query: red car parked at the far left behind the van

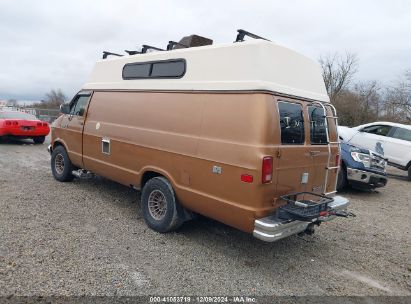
[0,110,50,144]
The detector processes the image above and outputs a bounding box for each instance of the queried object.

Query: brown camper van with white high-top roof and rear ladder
[49,32,349,241]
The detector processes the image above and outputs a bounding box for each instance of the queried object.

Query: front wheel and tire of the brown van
[51,146,74,182]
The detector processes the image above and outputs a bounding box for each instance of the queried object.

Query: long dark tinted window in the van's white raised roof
[123,59,186,79]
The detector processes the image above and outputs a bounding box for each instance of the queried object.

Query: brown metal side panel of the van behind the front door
[83,91,275,232]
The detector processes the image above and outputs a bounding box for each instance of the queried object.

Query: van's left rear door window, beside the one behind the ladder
[278,101,304,144]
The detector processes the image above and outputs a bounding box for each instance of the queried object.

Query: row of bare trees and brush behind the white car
[319,53,411,127]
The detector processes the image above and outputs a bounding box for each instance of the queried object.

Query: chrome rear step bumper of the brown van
[253,196,350,242]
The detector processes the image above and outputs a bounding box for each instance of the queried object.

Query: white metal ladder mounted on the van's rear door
[313,101,341,195]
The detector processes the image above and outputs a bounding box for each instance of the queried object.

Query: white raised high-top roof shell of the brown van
[83,39,329,102]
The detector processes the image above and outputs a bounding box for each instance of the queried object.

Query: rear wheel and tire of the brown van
[141,177,183,233]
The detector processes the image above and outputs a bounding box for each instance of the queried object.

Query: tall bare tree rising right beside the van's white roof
[319,53,358,102]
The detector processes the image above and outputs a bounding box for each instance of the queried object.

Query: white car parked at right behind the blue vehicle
[338,121,411,180]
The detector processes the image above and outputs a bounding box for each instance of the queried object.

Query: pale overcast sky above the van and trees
[0,0,411,100]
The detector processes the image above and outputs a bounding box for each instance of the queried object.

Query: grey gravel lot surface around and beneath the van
[0,137,411,296]
